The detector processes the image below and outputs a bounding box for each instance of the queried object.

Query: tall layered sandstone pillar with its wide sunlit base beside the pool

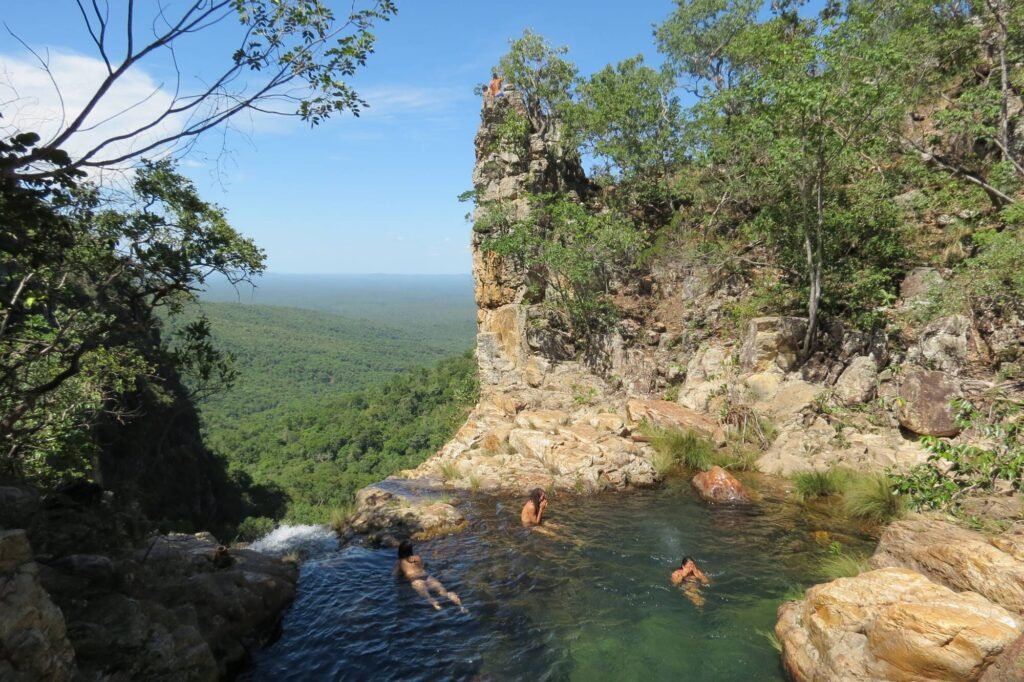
[353,93,671,541]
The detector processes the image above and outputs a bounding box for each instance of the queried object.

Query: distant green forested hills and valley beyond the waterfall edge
[176,275,476,525]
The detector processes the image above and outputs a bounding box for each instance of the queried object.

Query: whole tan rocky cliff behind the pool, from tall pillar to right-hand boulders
[353,95,950,536]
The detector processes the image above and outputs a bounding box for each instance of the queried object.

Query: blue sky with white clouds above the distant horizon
[0,0,675,273]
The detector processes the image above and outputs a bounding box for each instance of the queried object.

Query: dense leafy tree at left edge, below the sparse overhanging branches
[0,146,263,482]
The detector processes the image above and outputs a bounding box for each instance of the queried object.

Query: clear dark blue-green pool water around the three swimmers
[243,480,866,682]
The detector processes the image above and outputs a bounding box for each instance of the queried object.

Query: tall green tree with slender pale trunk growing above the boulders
[669,5,903,346]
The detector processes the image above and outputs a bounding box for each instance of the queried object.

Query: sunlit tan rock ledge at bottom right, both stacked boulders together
[775,516,1024,682]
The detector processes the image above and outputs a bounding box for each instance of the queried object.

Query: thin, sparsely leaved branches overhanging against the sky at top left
[0,0,396,178]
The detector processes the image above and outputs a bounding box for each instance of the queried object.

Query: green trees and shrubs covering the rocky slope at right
[482,0,1024,355]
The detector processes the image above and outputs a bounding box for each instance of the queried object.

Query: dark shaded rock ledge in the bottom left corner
[0,485,298,682]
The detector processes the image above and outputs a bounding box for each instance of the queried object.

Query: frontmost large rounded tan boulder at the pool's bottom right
[775,568,1024,682]
